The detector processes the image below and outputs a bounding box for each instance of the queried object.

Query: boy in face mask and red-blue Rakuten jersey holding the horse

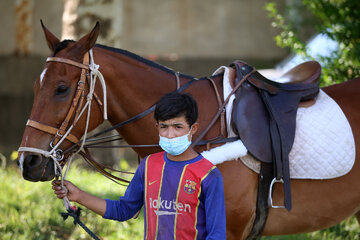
[53,92,226,240]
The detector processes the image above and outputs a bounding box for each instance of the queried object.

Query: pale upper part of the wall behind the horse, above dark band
[0,0,287,57]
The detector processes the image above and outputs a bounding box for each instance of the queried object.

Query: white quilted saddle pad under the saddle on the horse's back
[202,66,355,179]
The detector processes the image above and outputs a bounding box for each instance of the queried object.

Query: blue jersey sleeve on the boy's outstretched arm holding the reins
[103,160,145,221]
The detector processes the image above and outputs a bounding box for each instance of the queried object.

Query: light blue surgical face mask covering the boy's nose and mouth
[159,128,191,156]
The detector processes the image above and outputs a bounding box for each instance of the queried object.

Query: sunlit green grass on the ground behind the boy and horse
[0,161,360,240]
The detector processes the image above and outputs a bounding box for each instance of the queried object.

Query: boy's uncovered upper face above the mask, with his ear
[156,116,199,141]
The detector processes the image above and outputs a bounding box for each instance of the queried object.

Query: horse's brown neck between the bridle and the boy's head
[95,47,176,155]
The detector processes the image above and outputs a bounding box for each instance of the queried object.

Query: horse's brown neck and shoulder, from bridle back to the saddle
[95,46,223,156]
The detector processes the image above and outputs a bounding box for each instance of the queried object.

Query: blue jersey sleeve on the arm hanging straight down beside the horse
[202,168,226,240]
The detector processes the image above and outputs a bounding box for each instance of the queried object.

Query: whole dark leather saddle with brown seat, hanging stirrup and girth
[230,61,321,238]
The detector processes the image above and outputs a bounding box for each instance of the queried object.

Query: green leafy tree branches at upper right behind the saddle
[265,0,360,86]
